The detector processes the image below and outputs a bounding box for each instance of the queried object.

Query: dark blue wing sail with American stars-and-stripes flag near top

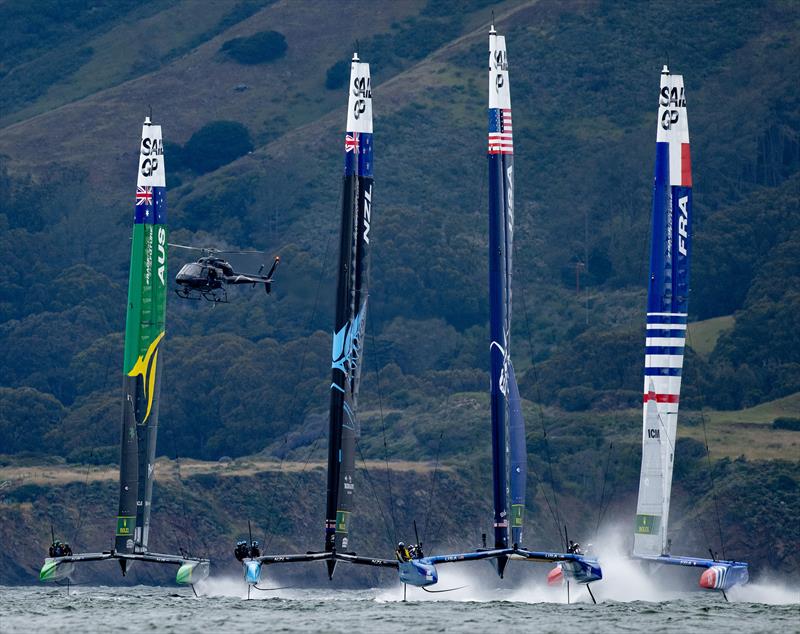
[488,26,526,576]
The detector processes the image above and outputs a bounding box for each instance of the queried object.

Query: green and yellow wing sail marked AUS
[114,117,167,573]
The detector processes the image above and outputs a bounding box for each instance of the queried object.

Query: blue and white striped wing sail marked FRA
[634,66,692,556]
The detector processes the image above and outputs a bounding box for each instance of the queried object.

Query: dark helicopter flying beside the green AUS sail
[169,242,281,304]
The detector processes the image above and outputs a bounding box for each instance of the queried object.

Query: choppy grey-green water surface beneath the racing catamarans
[0,579,800,634]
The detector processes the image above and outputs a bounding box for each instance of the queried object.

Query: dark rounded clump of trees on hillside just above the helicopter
[183,121,253,174]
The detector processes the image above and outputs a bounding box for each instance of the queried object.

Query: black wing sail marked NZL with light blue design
[325,54,372,577]
